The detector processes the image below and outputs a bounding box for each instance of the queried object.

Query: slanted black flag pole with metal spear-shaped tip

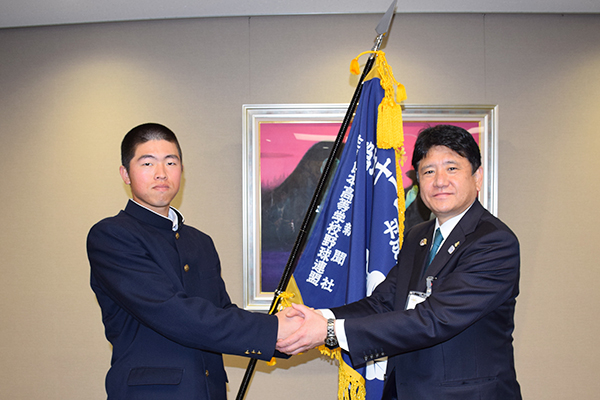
[236,0,397,400]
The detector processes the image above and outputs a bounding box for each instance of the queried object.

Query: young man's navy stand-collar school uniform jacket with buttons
[87,201,278,400]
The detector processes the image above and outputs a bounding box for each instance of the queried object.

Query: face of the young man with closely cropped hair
[120,140,183,216]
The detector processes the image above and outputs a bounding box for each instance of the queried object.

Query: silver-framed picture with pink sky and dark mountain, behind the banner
[242,104,498,311]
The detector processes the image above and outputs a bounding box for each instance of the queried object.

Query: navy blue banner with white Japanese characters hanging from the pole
[294,78,399,399]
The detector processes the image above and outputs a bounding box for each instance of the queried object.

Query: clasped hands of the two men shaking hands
[275,304,327,355]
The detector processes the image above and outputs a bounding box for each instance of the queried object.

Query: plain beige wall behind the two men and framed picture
[0,14,600,400]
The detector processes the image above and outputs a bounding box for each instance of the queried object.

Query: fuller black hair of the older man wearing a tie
[412,125,481,176]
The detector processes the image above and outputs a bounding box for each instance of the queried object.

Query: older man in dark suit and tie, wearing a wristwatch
[277,125,521,400]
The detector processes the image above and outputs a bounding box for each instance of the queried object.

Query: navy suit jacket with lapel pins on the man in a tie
[332,201,521,400]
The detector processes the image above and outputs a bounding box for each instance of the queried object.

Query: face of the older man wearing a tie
[418,146,483,224]
